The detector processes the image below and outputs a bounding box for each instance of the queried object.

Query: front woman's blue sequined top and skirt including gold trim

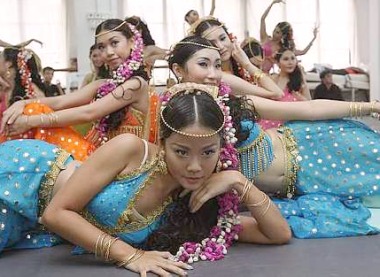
[0,140,171,252]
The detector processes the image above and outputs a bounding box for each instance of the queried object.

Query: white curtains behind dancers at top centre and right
[124,0,356,69]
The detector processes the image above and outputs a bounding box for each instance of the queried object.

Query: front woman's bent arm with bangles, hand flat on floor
[41,134,189,276]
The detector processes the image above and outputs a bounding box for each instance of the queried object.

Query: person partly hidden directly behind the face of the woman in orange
[80,44,110,88]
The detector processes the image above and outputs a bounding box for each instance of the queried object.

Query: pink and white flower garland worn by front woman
[161,83,242,263]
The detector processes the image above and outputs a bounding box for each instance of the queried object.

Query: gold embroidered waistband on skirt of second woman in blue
[278,126,300,198]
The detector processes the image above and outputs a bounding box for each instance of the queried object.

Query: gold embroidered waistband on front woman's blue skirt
[38,149,71,217]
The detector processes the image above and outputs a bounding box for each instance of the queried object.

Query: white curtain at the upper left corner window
[0,0,68,81]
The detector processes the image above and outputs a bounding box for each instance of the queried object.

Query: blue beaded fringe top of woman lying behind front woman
[237,129,274,182]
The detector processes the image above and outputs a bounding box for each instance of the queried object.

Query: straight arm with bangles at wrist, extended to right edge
[247,96,380,121]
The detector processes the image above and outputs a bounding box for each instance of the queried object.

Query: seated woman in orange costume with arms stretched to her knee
[0,19,159,160]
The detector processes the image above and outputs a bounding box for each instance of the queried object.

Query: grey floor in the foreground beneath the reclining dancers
[0,115,380,277]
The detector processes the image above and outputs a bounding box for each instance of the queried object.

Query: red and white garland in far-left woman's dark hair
[17,49,36,98]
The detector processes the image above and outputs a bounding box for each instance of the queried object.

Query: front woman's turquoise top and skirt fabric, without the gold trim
[0,140,166,253]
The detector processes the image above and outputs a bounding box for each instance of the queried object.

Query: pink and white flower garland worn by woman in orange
[95,23,144,144]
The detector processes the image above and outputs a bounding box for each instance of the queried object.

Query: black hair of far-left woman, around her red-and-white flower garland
[2,48,44,105]
